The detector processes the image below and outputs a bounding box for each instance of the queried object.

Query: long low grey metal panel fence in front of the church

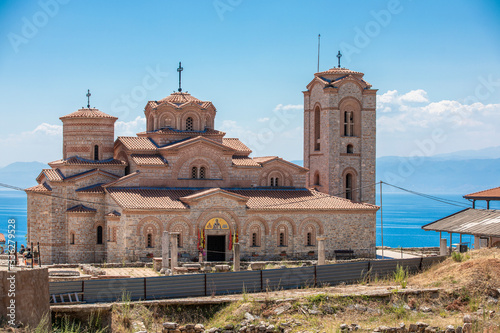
[49,256,446,303]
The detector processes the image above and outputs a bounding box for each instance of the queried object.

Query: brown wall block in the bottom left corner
[0,268,50,327]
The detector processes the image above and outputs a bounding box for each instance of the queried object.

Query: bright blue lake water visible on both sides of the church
[0,191,500,247]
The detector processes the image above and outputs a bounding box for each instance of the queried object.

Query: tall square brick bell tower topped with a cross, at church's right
[303,61,377,204]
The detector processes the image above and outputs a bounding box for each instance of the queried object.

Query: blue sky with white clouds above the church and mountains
[0,0,500,166]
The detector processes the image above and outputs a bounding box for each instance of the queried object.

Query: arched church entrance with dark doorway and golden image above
[205,217,230,261]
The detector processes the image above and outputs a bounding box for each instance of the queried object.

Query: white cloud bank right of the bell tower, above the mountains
[377,89,500,156]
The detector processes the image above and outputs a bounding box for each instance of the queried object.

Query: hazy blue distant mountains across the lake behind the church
[0,146,500,195]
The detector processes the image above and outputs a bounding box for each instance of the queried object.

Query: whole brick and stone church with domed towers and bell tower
[26,68,378,263]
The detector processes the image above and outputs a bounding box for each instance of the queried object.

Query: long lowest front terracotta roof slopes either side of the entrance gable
[107,188,378,211]
